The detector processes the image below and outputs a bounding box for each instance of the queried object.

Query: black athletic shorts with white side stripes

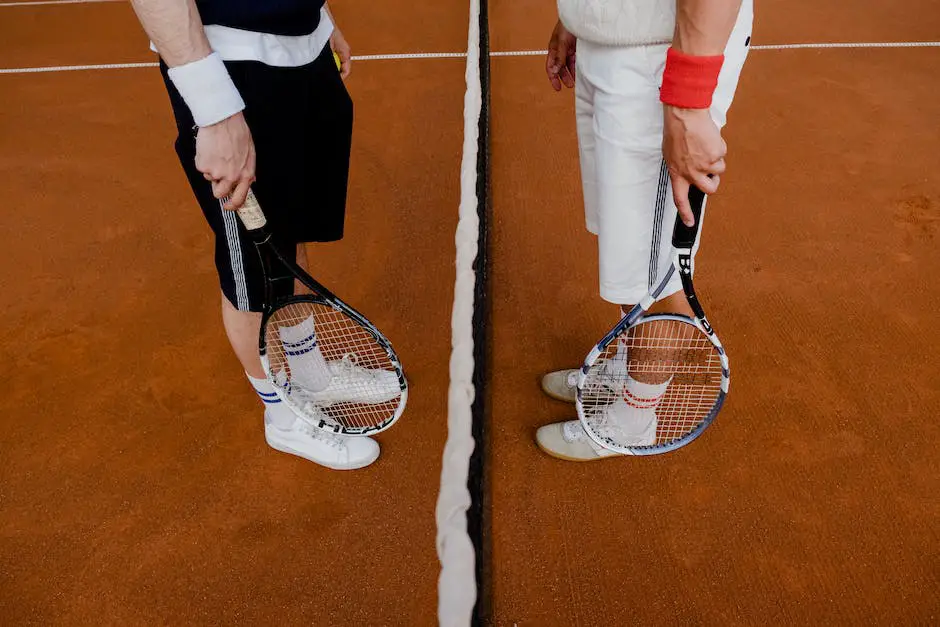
[161,45,353,311]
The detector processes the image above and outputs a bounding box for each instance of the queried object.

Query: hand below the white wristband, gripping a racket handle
[196,113,255,211]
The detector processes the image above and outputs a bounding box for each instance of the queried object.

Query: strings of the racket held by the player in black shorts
[264,301,401,429]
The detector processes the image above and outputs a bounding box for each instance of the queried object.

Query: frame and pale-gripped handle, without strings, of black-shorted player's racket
[236,190,408,436]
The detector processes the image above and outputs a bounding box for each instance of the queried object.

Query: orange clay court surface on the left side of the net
[0,2,466,625]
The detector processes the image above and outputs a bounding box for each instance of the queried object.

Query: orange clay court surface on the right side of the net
[488,0,940,627]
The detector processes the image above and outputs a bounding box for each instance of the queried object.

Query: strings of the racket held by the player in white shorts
[581,319,723,448]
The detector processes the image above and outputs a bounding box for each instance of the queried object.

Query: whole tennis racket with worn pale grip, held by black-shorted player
[238,191,408,436]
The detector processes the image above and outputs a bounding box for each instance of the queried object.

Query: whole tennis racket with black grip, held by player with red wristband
[575,186,730,455]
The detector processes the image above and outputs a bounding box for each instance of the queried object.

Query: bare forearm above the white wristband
[131,0,212,67]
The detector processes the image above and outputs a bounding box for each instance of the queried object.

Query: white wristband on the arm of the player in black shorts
[167,52,245,126]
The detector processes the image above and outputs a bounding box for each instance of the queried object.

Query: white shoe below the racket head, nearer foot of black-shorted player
[264,412,379,470]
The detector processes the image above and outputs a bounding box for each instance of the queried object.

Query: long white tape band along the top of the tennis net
[436,0,483,627]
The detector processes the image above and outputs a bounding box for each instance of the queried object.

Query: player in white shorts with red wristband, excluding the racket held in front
[536,0,753,461]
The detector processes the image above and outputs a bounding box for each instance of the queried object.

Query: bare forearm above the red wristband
[672,0,741,56]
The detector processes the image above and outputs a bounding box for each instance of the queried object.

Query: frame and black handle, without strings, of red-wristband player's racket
[575,186,731,456]
